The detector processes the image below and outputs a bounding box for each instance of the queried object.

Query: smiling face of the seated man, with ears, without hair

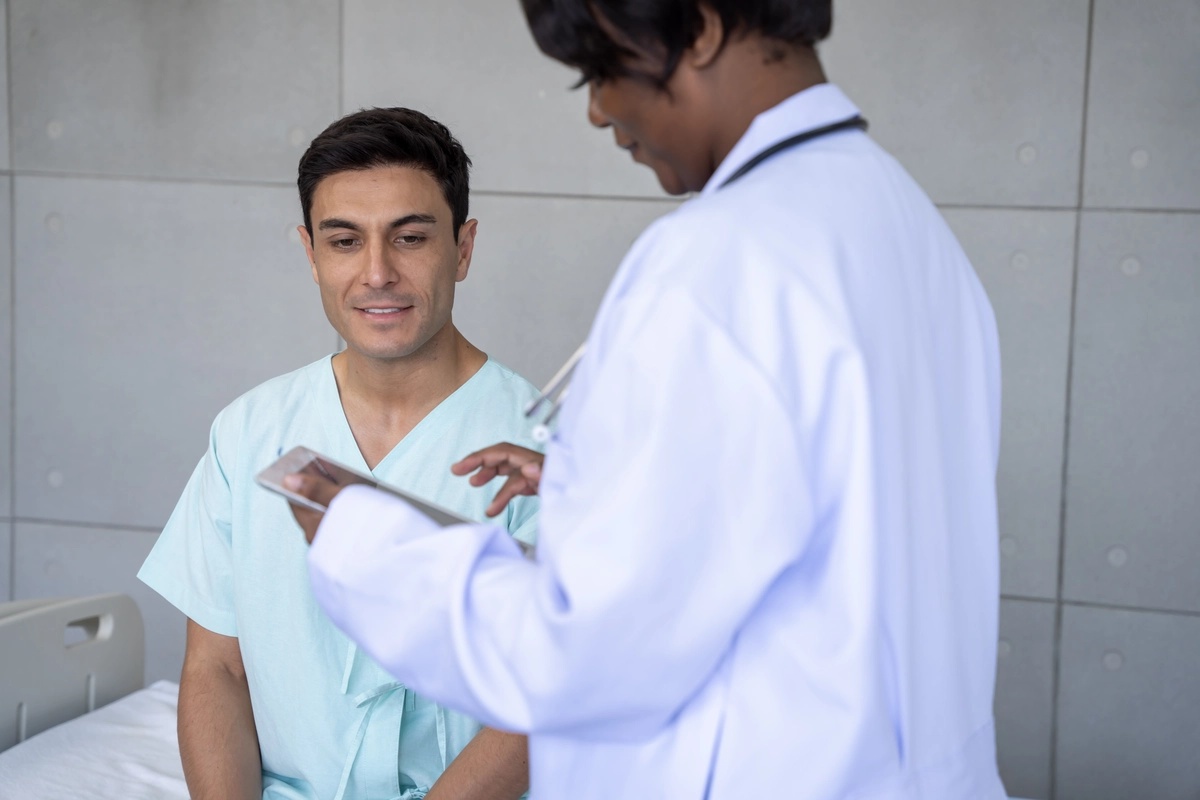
[300,167,476,360]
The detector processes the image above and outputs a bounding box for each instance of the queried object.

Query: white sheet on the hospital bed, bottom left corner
[0,680,188,800]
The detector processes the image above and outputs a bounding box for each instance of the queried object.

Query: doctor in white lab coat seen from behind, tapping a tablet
[285,0,1004,800]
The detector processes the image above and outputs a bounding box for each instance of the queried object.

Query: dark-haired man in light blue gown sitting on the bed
[139,108,536,800]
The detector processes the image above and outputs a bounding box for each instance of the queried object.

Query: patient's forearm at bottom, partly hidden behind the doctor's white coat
[425,728,529,800]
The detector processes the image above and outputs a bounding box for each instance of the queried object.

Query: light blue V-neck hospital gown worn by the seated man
[138,356,536,800]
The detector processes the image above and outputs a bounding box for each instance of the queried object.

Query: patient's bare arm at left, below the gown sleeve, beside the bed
[179,620,263,800]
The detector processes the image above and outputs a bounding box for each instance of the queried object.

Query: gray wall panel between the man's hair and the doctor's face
[344,0,661,197]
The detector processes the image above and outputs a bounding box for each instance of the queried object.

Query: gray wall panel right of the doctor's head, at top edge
[826,0,1089,206]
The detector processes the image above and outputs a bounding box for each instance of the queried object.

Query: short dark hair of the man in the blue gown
[296,108,470,239]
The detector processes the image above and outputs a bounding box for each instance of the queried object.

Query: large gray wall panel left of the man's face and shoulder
[16,176,336,528]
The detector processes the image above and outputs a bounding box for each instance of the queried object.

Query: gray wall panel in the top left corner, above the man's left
[10,0,340,181]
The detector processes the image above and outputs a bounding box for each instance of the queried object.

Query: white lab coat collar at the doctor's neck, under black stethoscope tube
[701,83,858,196]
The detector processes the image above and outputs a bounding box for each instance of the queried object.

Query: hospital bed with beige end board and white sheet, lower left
[0,595,187,800]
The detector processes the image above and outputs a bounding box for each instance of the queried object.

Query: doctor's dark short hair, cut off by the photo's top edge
[521,0,833,88]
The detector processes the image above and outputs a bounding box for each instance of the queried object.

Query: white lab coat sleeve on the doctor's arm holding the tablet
[310,290,830,740]
